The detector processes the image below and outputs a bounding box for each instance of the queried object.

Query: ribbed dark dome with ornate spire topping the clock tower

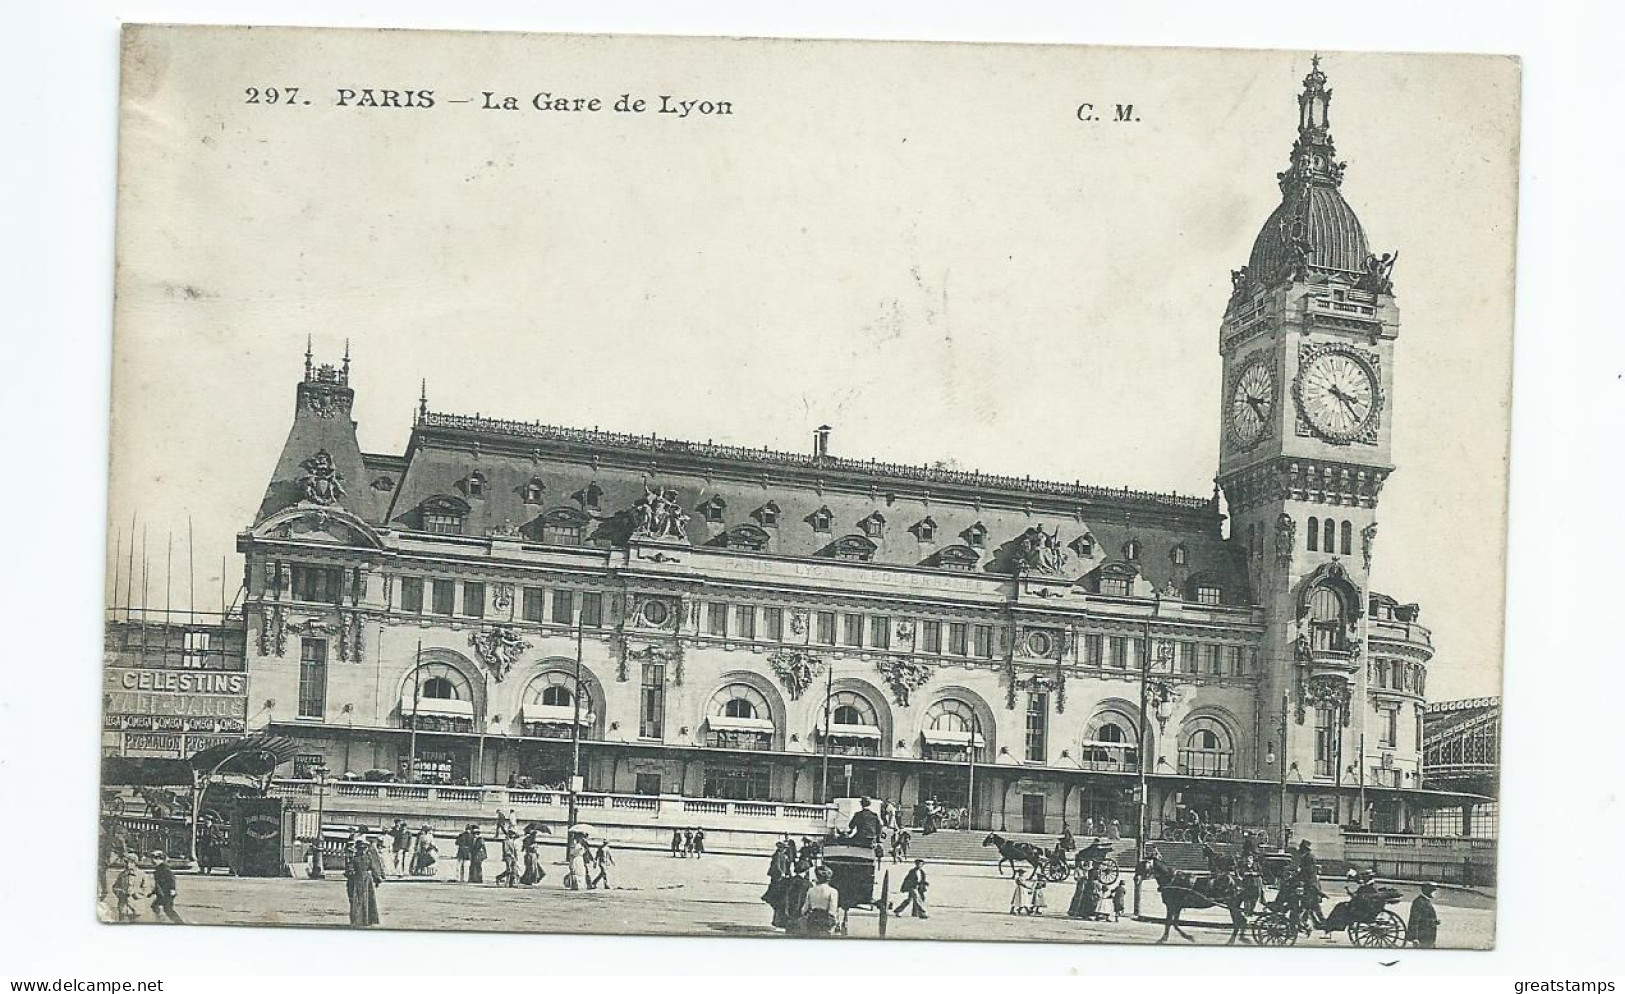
[1246,55,1372,286]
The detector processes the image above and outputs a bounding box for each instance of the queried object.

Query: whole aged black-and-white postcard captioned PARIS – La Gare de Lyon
[98,26,1519,949]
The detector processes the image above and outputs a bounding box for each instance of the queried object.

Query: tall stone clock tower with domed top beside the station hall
[1219,57,1399,836]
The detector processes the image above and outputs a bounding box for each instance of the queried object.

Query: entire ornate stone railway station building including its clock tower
[239,60,1432,833]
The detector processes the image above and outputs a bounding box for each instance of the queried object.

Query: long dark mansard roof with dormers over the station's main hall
[359,413,1250,603]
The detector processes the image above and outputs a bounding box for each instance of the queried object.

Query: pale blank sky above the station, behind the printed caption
[109,29,1518,700]
